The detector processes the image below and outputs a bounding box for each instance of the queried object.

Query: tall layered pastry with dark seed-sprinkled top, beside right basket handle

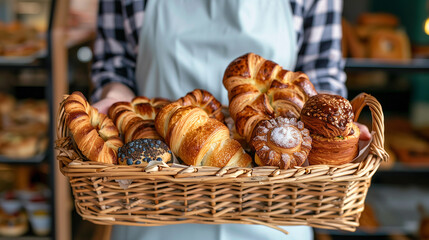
[301,94,360,165]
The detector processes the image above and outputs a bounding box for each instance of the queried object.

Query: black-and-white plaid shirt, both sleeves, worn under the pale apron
[92,0,347,101]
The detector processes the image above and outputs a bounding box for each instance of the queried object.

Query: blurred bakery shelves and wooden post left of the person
[0,0,100,239]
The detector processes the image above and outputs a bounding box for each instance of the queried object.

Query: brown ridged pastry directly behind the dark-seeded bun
[108,96,170,143]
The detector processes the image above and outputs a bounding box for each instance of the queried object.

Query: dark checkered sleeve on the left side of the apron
[91,0,137,102]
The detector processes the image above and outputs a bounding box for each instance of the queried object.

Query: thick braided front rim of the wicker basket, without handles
[56,137,383,184]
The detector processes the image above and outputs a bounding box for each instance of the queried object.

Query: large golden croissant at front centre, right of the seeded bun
[155,89,252,167]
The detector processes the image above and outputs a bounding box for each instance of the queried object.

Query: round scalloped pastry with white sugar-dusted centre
[250,117,311,169]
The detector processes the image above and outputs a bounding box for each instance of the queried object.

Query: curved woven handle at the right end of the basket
[350,93,389,161]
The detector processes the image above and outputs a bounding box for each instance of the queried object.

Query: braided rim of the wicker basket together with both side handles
[55,93,388,182]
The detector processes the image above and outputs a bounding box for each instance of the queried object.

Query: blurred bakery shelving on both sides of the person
[0,0,429,240]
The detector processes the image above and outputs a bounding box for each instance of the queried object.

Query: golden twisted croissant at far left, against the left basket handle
[62,92,123,164]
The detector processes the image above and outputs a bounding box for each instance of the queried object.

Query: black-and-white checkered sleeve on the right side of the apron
[296,0,347,97]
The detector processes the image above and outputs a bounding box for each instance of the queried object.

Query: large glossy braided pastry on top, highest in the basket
[223,53,317,142]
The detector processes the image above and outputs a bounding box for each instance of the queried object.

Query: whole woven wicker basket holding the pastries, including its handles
[56,93,388,231]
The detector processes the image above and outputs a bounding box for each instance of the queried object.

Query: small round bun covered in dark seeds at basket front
[118,138,172,165]
